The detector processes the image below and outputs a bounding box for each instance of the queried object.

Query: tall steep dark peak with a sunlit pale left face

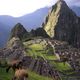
[42,0,80,47]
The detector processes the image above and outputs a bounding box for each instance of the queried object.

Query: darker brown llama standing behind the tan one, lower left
[6,59,22,72]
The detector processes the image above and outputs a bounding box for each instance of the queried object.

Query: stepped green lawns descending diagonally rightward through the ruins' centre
[24,40,71,71]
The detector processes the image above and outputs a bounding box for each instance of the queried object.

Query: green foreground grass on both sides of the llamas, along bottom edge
[0,68,52,80]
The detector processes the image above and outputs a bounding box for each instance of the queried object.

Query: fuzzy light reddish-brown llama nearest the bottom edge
[12,68,28,80]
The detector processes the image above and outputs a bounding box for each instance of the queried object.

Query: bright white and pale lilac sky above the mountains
[0,0,80,17]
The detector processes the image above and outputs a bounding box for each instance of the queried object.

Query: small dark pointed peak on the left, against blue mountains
[10,23,29,40]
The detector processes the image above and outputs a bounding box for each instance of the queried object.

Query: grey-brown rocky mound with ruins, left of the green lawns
[0,37,27,60]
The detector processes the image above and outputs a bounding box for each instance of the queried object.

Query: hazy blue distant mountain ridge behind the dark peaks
[0,6,80,46]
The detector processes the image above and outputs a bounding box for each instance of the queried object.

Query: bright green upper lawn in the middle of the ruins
[24,41,55,60]
